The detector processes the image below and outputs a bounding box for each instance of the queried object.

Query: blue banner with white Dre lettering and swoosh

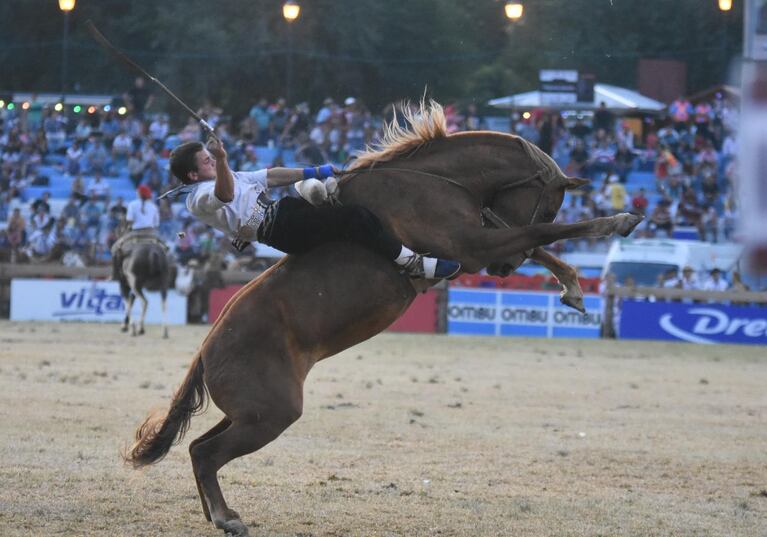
[620,300,767,345]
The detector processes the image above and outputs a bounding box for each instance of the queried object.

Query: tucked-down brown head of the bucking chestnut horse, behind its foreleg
[487,175,589,277]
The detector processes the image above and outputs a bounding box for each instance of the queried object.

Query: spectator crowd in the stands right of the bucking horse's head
[514,95,738,251]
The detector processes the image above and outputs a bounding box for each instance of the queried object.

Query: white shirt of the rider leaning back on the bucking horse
[186,170,267,241]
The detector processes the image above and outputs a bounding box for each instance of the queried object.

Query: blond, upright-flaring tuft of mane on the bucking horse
[349,99,447,170]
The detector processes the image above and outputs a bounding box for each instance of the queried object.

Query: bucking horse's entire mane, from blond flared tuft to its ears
[348,99,563,183]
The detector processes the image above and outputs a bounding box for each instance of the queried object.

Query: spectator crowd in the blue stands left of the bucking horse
[0,91,480,268]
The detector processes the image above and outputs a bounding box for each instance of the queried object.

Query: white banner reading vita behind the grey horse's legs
[11,279,186,324]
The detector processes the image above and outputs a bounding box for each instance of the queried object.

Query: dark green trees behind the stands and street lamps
[0,0,742,114]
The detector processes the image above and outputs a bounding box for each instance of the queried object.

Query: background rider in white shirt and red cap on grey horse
[112,185,167,280]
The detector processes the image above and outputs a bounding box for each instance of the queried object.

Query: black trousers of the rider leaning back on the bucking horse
[263,197,402,259]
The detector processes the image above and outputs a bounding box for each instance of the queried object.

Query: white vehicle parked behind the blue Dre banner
[602,239,743,286]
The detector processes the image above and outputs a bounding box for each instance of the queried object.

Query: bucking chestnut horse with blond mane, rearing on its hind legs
[126,103,640,535]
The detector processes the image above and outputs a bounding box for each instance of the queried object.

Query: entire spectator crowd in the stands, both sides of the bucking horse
[0,80,738,280]
